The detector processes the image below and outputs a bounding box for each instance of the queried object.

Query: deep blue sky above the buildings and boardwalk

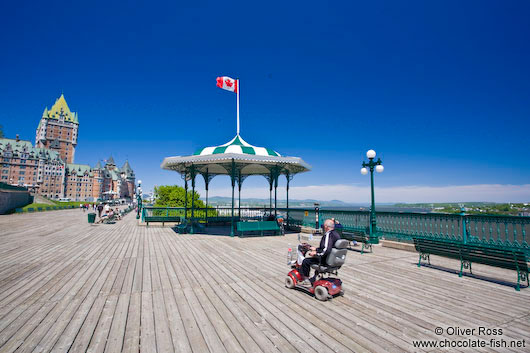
[0,1,530,202]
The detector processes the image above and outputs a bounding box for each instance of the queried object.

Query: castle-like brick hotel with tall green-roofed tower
[0,94,135,201]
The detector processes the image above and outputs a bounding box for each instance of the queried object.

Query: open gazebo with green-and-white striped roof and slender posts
[161,134,311,236]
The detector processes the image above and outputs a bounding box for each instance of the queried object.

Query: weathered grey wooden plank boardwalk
[0,210,530,353]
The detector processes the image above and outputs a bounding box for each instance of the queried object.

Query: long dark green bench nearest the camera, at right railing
[413,236,529,290]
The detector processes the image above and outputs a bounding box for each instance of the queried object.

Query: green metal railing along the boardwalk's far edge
[138,207,530,252]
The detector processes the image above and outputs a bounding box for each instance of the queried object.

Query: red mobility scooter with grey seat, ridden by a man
[285,239,348,301]
